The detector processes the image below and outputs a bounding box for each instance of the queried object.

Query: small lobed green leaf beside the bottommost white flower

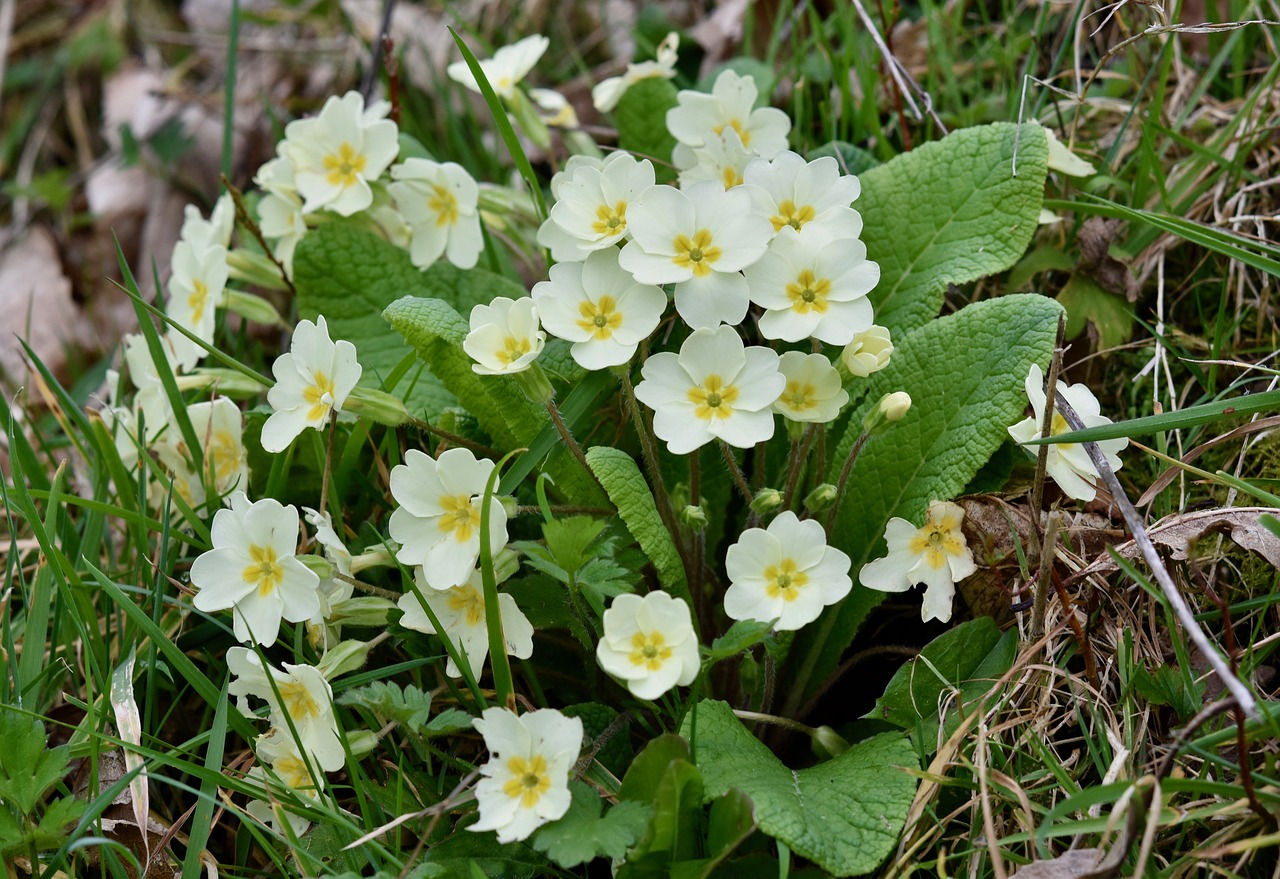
[532,782,650,870]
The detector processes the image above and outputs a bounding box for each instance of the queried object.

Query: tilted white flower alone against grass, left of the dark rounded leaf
[262,315,362,452]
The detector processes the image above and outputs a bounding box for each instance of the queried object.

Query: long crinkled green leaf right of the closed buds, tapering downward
[782,294,1061,717]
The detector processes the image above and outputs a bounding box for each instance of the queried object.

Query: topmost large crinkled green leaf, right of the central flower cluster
[854,123,1048,339]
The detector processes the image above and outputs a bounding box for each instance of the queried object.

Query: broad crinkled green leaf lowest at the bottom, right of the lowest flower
[682,700,916,876]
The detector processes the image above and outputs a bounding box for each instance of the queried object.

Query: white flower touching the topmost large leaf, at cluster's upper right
[742,150,863,239]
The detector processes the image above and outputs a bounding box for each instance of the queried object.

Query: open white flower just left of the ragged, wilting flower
[724,511,854,631]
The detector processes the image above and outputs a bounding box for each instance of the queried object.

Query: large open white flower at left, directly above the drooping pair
[191,491,320,646]
